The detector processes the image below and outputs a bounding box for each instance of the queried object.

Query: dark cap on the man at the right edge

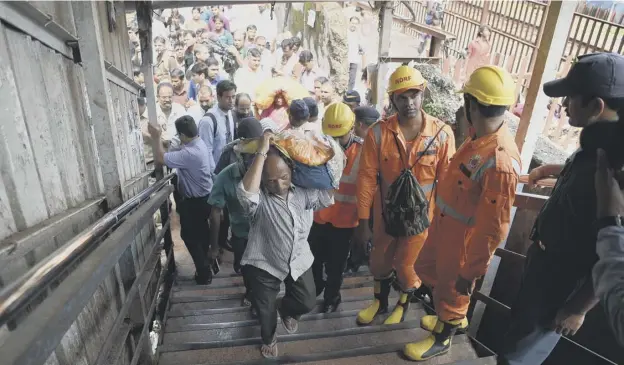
[544,53,624,98]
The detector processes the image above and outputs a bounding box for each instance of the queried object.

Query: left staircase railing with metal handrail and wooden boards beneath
[0,174,175,365]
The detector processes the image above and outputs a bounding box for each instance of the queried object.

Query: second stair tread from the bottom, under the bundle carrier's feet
[163,308,425,347]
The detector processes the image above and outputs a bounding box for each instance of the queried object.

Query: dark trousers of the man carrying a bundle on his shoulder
[243,265,316,345]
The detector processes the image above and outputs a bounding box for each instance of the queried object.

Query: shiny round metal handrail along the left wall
[0,173,175,327]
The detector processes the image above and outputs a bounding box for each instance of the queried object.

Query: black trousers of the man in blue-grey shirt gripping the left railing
[177,196,212,279]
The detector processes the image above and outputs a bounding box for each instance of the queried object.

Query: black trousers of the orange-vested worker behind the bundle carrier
[308,223,353,301]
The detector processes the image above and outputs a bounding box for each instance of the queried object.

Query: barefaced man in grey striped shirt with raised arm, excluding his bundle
[237,133,334,358]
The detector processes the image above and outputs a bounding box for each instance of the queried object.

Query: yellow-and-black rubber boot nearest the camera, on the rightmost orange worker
[403,319,462,361]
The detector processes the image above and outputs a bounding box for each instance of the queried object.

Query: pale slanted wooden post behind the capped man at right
[516,1,576,173]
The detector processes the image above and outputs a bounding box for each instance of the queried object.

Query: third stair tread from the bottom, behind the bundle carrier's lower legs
[165,298,410,332]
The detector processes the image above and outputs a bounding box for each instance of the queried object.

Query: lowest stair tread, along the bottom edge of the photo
[159,328,477,365]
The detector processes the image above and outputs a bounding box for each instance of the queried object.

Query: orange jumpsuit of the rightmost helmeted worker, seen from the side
[414,125,520,322]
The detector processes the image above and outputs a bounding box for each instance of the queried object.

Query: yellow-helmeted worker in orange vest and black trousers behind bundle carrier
[308,103,364,313]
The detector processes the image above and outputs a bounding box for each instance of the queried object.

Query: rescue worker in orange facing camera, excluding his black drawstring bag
[354,66,455,325]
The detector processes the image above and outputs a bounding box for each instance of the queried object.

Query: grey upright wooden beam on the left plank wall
[71,1,123,208]
